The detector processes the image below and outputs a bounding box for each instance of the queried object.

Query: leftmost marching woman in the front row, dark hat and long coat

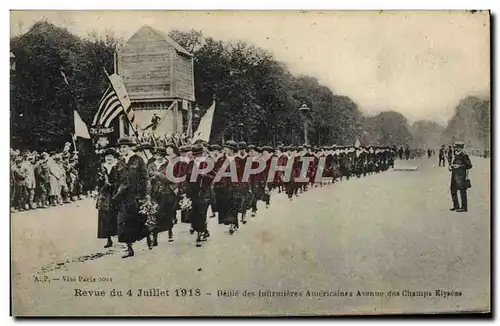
[96,148,120,248]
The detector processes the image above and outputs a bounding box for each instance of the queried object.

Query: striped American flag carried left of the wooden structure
[93,86,135,128]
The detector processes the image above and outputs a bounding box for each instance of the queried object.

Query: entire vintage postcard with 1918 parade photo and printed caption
[10,10,491,316]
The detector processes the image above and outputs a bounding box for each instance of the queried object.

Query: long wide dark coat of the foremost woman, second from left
[115,154,148,243]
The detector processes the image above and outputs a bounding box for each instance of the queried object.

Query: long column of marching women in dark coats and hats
[96,138,397,258]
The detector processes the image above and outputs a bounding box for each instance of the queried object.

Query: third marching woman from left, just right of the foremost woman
[148,147,176,247]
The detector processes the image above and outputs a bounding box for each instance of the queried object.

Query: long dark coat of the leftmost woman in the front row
[96,164,120,239]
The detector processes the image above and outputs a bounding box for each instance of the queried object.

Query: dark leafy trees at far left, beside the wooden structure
[11,21,119,150]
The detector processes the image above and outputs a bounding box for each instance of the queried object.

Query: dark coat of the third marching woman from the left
[148,160,177,233]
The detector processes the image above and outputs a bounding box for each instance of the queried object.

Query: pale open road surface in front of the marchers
[11,157,490,316]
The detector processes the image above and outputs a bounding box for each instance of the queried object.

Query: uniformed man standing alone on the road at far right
[448,141,472,212]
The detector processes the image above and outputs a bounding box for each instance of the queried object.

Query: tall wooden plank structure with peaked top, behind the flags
[115,25,195,137]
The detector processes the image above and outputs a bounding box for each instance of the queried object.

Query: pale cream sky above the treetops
[11,11,490,124]
